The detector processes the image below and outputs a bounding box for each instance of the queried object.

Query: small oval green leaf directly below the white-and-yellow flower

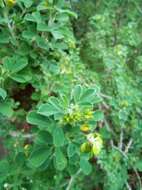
[80,157,92,175]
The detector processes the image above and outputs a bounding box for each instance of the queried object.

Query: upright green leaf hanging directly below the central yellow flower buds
[53,127,65,147]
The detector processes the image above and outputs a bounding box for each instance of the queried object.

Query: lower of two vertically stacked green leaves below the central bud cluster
[55,148,67,171]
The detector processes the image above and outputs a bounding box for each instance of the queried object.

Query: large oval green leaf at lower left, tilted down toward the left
[28,147,51,168]
